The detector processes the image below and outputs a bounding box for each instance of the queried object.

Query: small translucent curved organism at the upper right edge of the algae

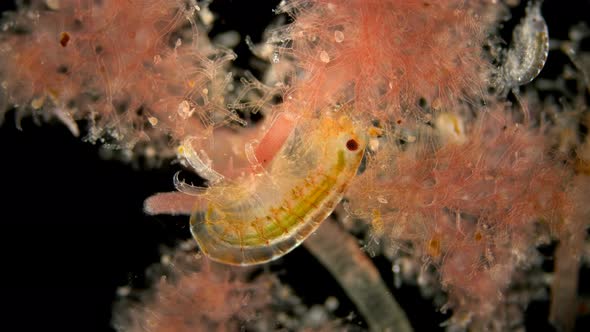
[501,0,549,92]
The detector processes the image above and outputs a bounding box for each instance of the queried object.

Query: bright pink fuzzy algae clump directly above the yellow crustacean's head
[275,0,502,120]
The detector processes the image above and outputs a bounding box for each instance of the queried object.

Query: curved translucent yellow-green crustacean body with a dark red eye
[190,113,367,265]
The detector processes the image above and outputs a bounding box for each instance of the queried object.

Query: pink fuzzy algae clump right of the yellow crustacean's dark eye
[349,108,570,318]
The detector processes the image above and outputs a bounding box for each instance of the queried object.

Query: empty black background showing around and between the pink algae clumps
[0,0,590,331]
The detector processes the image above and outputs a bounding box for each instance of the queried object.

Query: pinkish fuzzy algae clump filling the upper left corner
[0,0,236,161]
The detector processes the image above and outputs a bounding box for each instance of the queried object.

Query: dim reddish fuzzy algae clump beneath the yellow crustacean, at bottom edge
[113,242,354,332]
